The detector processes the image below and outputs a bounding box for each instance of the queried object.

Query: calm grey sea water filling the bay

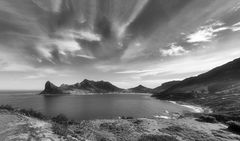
[0,91,197,120]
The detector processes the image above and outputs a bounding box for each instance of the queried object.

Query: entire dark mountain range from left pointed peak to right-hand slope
[41,58,240,96]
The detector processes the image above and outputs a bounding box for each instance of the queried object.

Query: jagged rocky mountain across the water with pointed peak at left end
[41,79,123,94]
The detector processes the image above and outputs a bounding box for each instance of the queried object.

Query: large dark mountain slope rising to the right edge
[155,58,240,100]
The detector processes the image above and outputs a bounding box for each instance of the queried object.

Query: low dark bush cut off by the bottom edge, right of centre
[138,135,178,141]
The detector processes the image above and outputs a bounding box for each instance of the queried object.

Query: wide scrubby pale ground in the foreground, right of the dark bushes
[69,118,240,141]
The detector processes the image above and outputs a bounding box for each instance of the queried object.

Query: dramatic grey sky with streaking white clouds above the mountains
[0,0,240,90]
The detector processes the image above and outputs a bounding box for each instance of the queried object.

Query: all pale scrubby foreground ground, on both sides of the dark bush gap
[0,111,240,141]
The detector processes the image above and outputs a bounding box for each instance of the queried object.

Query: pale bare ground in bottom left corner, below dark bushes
[0,111,63,141]
